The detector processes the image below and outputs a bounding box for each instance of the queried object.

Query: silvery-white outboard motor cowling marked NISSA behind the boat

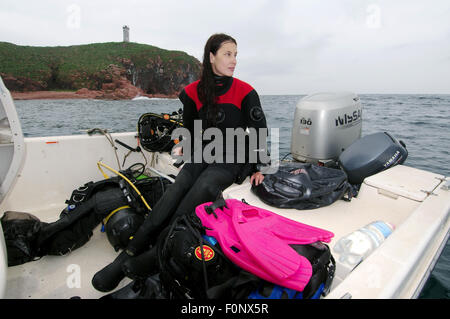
[291,92,362,163]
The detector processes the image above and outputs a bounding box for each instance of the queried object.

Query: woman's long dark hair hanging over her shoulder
[198,33,237,124]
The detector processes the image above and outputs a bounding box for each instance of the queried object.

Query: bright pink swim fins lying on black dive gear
[196,199,334,291]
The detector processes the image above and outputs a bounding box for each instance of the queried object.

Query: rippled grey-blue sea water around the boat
[15,94,450,298]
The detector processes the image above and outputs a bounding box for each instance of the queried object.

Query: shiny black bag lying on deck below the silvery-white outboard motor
[251,162,355,210]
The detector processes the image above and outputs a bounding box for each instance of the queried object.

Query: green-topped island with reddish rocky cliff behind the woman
[0,42,201,99]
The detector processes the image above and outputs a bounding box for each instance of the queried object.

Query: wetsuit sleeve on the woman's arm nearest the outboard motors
[241,89,269,172]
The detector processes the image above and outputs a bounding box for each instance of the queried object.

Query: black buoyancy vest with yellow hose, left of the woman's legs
[47,164,170,255]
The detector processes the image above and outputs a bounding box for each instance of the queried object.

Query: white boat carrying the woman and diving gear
[0,80,450,299]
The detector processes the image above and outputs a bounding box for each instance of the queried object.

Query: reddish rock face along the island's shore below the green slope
[0,56,200,99]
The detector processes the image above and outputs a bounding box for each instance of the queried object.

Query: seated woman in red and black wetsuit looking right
[92,34,267,292]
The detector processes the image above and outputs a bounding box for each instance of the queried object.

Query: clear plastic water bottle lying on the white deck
[333,221,395,269]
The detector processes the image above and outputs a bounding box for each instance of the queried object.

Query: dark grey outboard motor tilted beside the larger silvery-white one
[338,132,408,184]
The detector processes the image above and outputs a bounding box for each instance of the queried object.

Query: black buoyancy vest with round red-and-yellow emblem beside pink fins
[157,214,240,299]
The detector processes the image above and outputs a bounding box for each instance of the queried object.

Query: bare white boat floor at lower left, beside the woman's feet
[4,210,131,299]
